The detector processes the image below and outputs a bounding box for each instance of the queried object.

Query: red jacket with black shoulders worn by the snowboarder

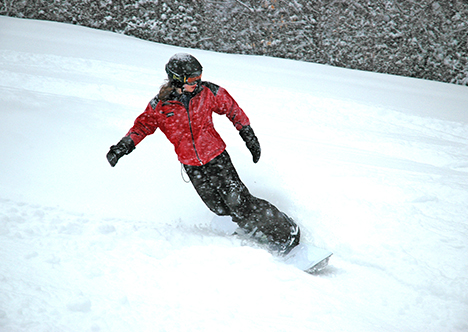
[127,82,250,166]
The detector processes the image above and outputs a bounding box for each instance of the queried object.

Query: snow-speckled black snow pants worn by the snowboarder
[184,151,300,254]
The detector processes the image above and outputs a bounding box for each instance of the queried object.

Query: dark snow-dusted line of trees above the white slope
[0,0,468,85]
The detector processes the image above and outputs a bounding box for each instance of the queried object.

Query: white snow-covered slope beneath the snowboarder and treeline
[0,17,468,332]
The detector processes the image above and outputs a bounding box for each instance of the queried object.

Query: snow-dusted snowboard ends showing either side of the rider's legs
[211,216,333,274]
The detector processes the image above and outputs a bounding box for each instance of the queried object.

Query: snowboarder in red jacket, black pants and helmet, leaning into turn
[107,53,300,255]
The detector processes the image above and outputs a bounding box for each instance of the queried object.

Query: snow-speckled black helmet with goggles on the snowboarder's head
[166,53,203,87]
